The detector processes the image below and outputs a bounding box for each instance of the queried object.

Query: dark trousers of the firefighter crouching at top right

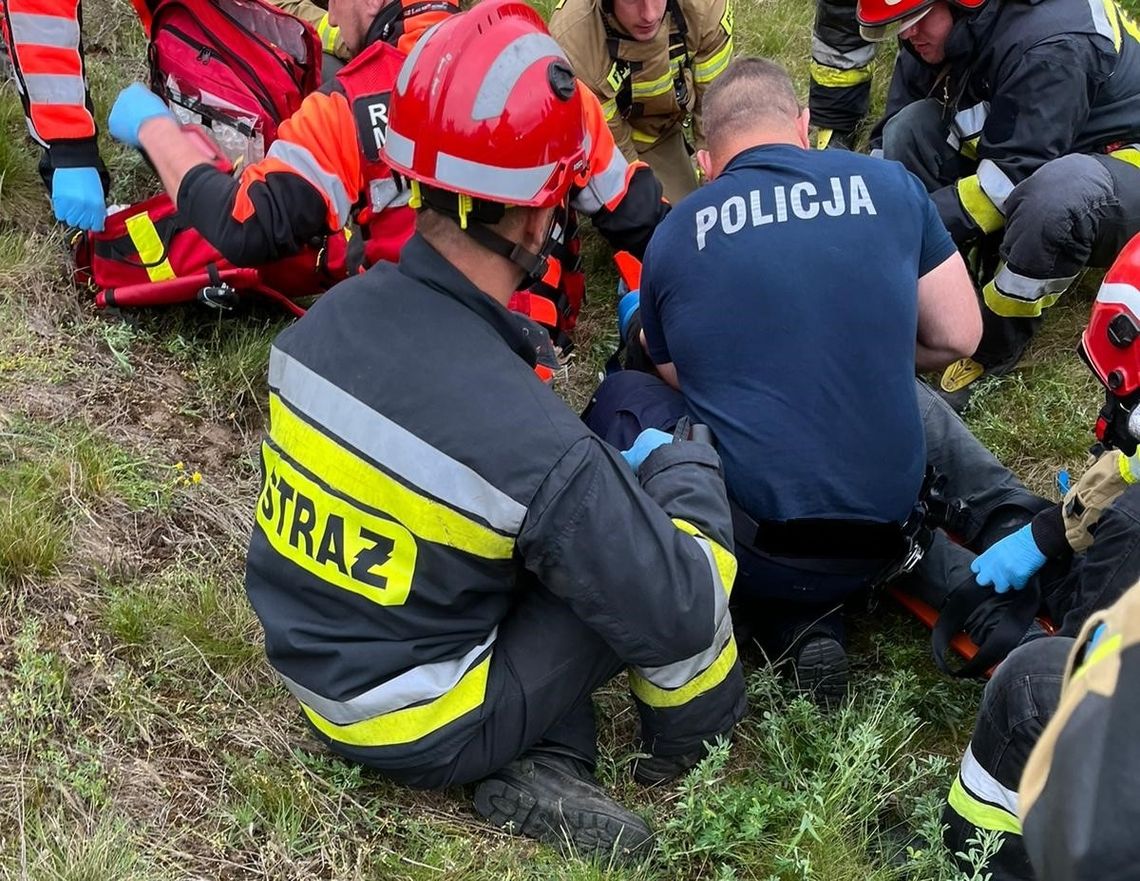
[882,98,1140,367]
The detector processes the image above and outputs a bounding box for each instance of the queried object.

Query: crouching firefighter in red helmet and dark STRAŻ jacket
[246,0,744,856]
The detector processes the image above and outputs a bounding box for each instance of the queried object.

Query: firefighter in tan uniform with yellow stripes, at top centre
[551,0,733,203]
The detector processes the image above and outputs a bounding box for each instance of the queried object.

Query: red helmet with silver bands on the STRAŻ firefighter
[383,0,586,207]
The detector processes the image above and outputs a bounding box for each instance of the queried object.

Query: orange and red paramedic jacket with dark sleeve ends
[169,6,668,287]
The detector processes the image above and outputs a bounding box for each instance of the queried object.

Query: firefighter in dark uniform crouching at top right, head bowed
[857,0,1140,409]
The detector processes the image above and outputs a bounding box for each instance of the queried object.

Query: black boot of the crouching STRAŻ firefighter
[474,750,653,862]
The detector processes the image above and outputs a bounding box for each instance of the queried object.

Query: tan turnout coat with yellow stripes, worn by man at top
[551,0,733,161]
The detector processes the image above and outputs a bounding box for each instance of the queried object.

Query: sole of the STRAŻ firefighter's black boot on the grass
[474,780,651,860]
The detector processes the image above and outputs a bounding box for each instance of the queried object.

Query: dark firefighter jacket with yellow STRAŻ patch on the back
[246,236,743,768]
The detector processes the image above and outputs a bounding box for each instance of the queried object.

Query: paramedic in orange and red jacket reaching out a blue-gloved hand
[111,0,668,348]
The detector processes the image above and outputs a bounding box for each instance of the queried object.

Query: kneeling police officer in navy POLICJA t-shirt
[641,58,982,700]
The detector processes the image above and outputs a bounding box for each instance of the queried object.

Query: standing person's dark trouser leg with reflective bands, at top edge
[807,0,876,149]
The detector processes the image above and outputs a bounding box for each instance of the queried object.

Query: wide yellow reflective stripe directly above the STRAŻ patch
[269,392,514,560]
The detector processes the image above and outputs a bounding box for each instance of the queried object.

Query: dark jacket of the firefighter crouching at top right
[879,0,1140,243]
